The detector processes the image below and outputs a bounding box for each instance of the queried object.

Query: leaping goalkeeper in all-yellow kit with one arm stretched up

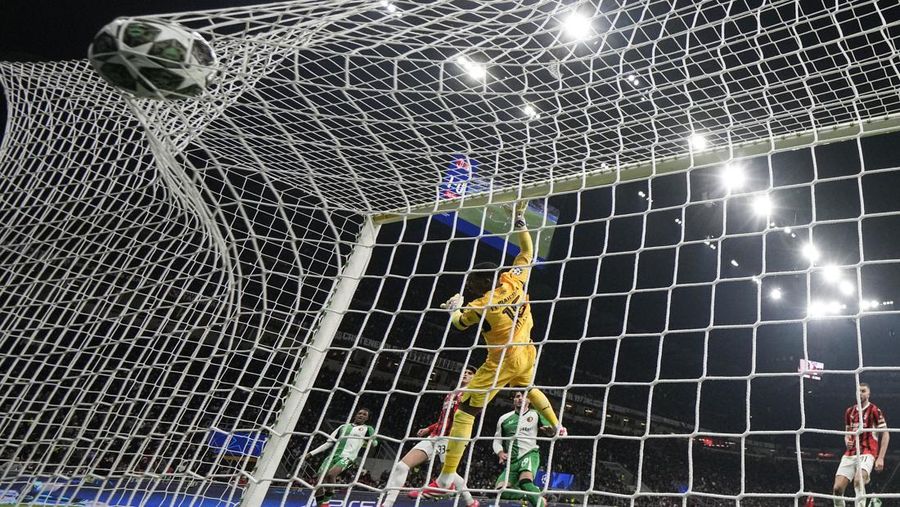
[437,202,566,491]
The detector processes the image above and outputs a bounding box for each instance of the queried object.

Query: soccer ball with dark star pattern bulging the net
[88,18,218,99]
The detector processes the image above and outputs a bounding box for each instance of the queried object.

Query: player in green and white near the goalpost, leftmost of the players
[304,408,378,507]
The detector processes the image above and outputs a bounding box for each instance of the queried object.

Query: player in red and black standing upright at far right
[833,383,891,507]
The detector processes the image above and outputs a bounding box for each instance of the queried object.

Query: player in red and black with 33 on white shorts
[381,367,478,507]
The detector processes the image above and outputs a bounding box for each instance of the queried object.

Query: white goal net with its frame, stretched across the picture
[0,0,900,506]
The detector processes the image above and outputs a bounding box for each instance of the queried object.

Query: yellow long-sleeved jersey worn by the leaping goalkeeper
[456,253,534,362]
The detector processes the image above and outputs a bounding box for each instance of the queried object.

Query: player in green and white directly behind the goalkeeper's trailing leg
[494,391,556,507]
